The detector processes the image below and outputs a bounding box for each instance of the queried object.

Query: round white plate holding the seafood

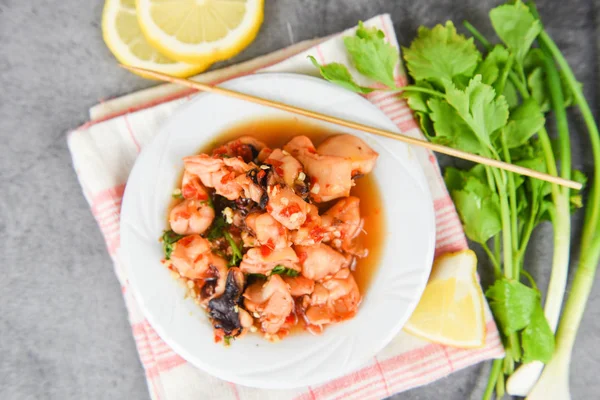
[121,73,435,389]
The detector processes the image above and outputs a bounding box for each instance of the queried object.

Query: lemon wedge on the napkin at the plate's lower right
[404,250,485,348]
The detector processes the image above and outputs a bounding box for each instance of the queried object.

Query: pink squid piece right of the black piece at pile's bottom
[244,275,294,335]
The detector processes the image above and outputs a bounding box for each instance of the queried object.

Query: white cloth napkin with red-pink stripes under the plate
[68,15,504,400]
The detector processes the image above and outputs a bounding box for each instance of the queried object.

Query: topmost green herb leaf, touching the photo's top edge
[490,1,542,62]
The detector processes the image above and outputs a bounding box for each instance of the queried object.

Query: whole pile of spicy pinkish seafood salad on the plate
[162,134,378,344]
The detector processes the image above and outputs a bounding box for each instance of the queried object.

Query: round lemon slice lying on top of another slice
[136,0,264,63]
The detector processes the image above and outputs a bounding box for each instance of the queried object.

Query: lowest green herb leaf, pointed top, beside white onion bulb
[521,300,555,363]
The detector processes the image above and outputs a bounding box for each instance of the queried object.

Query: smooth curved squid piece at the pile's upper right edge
[317,135,379,177]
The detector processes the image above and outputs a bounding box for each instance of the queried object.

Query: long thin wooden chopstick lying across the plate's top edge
[121,64,582,190]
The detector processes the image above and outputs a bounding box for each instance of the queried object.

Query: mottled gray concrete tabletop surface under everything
[0,0,600,400]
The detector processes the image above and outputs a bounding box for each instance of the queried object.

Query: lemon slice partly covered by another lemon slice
[102,0,210,77]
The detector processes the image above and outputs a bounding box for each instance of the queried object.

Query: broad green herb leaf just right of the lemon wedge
[485,279,540,335]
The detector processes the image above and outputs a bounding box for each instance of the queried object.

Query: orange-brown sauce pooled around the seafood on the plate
[198,118,385,295]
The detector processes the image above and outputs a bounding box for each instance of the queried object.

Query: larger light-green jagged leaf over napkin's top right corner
[344,21,400,89]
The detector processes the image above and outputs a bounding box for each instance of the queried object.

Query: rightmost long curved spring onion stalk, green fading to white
[527,31,600,400]
